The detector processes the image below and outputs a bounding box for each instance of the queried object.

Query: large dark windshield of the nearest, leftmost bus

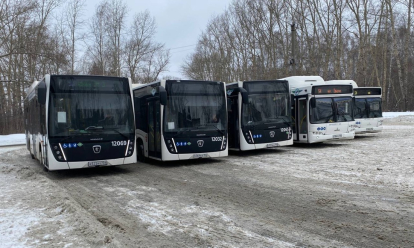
[49,76,134,137]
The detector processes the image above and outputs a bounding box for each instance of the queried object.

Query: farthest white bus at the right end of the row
[326,80,383,134]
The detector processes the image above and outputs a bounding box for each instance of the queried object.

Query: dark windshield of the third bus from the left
[242,81,291,126]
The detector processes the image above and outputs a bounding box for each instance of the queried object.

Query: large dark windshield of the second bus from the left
[164,81,227,133]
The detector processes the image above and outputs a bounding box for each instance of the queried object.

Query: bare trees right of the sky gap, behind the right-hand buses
[182,0,414,111]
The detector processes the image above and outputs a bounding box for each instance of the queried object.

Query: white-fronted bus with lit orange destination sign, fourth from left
[284,76,355,143]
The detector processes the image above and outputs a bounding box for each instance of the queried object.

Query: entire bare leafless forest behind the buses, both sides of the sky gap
[0,0,414,134]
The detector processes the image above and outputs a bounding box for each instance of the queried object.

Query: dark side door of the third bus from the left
[227,94,240,148]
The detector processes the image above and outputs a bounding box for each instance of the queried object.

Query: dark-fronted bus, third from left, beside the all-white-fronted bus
[226,80,293,151]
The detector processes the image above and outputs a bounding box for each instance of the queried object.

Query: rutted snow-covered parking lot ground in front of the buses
[0,112,414,248]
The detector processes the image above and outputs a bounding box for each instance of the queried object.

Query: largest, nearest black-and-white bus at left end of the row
[24,75,136,171]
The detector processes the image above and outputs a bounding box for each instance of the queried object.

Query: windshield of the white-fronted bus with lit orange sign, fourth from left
[310,97,354,124]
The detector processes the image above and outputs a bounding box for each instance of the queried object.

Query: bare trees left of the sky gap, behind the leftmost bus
[0,0,170,134]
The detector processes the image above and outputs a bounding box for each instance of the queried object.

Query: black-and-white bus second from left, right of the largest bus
[133,80,228,161]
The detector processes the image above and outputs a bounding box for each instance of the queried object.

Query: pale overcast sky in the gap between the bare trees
[86,0,232,79]
